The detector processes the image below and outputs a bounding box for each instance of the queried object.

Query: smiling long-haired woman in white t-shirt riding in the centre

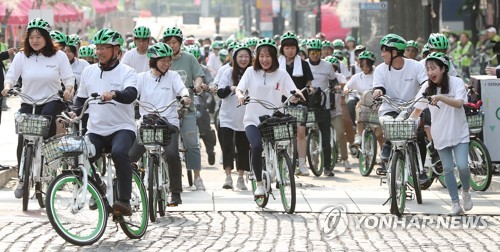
[236,38,304,196]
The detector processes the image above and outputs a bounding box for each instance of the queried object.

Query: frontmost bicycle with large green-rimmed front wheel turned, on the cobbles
[46,93,148,246]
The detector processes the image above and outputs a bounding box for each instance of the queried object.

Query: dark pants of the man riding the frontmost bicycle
[88,130,135,201]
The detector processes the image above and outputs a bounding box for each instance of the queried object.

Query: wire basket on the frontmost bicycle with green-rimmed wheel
[42,135,85,164]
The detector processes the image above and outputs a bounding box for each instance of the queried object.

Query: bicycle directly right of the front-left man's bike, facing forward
[136,96,181,222]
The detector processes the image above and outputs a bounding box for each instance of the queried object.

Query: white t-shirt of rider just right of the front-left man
[137,71,189,127]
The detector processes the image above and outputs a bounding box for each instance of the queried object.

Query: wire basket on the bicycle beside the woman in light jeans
[382,121,418,141]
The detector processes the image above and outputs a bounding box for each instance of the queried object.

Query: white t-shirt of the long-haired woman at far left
[4,50,75,104]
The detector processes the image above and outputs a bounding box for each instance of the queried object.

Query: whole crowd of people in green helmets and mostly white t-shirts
[2,18,498,219]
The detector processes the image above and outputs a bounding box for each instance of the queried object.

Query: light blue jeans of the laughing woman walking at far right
[438,143,470,203]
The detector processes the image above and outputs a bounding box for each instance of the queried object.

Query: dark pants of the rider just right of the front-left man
[129,127,182,193]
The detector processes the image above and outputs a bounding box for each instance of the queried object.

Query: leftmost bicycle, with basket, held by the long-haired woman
[8,89,62,211]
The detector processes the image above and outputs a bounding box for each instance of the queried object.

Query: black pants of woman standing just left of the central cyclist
[219,127,250,171]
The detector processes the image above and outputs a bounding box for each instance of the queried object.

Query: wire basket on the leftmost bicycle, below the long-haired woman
[16,114,51,137]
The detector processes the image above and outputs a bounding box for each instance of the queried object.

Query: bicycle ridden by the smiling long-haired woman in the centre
[240,92,297,214]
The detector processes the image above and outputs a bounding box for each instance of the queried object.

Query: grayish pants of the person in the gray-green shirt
[181,112,201,171]
